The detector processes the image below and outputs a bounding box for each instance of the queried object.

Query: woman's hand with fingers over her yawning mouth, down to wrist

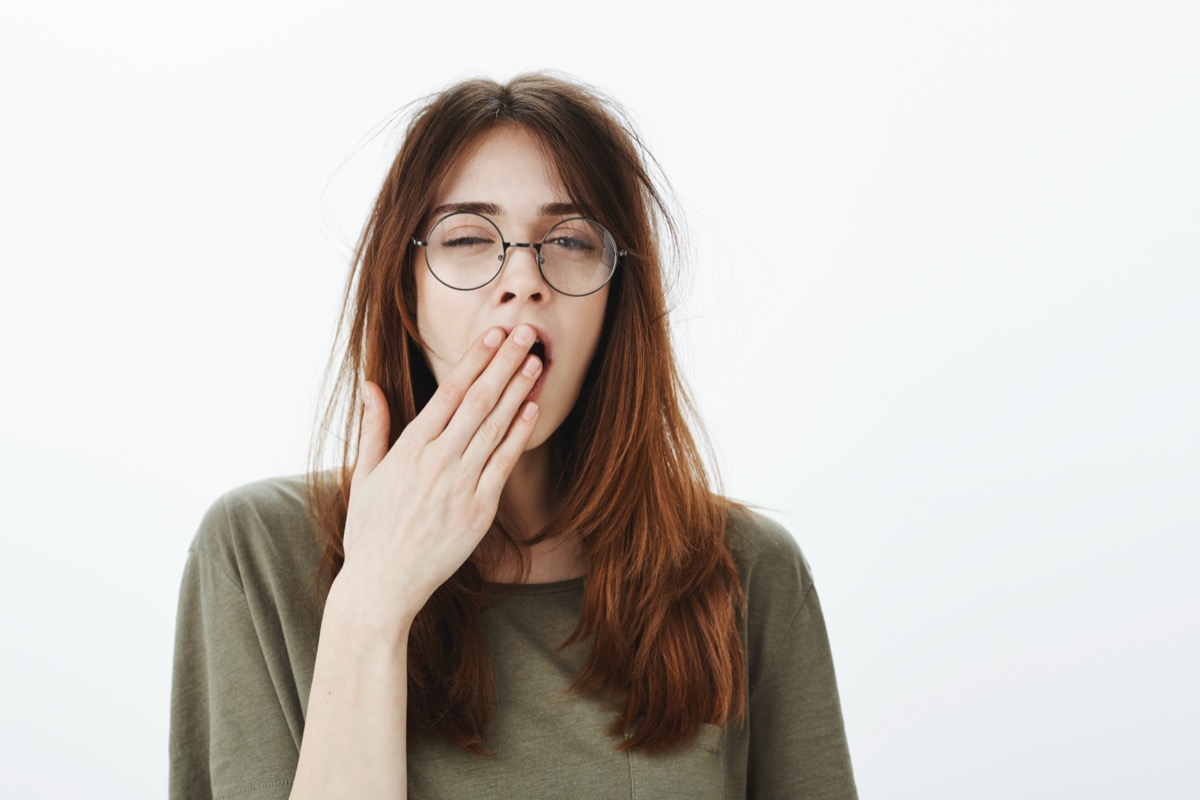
[334,325,541,631]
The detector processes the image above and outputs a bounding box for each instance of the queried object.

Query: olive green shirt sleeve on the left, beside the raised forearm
[169,503,299,800]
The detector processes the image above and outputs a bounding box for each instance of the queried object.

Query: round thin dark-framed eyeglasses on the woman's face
[413,211,625,297]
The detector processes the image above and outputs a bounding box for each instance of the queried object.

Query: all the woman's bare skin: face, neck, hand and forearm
[290,127,607,800]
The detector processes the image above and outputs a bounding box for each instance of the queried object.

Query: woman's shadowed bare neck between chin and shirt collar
[486,441,587,583]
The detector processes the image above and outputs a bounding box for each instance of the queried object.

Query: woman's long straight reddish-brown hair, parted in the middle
[308,73,745,753]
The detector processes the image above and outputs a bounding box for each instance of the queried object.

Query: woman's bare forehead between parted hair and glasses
[434,125,570,218]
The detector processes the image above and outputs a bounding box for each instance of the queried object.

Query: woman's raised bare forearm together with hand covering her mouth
[285,335,541,800]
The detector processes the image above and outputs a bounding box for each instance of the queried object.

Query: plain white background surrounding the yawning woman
[0,0,1200,799]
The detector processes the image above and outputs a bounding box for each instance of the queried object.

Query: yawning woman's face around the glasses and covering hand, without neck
[414,125,608,450]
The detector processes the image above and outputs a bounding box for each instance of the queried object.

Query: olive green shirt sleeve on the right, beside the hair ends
[746,584,858,800]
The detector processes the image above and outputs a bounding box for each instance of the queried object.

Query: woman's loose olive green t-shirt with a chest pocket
[169,475,857,800]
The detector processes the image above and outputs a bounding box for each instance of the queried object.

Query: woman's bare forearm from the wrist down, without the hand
[290,583,408,800]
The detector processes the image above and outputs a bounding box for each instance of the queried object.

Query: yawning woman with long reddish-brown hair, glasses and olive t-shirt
[170,74,854,800]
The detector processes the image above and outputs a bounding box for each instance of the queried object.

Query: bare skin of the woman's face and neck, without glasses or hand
[415,125,608,583]
